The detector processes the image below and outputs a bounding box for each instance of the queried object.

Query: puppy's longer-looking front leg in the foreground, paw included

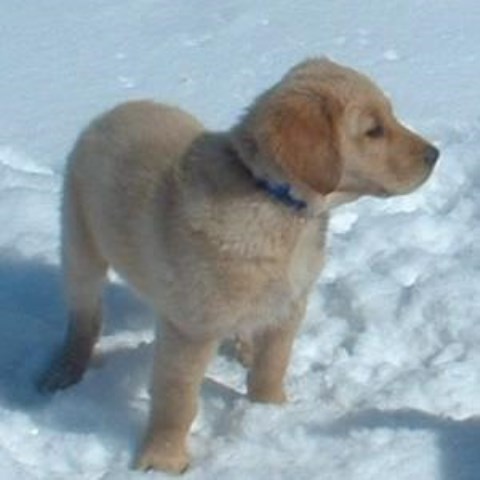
[136,325,217,473]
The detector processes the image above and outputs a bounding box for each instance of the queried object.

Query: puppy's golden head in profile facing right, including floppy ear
[234,59,439,204]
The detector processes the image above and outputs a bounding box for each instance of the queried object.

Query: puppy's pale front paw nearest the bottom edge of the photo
[135,444,189,474]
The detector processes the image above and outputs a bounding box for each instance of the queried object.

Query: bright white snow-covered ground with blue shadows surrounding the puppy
[0,0,480,480]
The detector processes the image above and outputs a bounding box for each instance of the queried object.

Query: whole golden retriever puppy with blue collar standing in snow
[42,59,439,472]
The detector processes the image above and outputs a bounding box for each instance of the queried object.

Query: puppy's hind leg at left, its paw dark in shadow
[39,178,108,392]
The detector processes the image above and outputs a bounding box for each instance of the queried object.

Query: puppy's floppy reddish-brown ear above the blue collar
[256,93,342,195]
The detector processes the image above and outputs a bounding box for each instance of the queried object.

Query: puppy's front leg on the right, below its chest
[247,306,305,404]
